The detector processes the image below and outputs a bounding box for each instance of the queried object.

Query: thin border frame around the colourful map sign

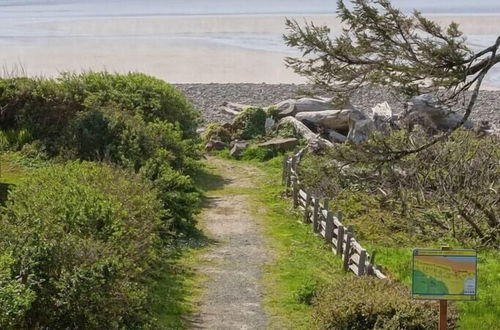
[411,248,478,301]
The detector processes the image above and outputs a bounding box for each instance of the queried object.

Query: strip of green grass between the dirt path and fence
[244,157,350,329]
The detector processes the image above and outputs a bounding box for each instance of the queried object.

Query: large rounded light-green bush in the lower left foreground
[0,162,166,329]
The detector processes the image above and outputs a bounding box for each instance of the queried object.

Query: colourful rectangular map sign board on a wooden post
[412,249,477,300]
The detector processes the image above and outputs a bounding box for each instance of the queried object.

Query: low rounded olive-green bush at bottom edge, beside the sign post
[313,277,457,330]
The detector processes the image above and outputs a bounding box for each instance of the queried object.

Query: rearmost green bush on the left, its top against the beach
[0,72,199,140]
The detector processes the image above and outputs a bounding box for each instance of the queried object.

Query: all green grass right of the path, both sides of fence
[232,158,500,330]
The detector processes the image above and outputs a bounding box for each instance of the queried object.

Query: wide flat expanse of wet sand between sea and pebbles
[0,15,500,86]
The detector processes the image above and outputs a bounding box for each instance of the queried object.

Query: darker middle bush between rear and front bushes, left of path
[66,109,199,172]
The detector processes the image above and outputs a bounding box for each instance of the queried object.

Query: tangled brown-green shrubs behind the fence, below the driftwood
[300,131,500,247]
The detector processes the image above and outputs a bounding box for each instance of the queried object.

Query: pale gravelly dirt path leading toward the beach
[192,158,267,329]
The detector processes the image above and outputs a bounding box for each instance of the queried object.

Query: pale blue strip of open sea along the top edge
[0,0,500,20]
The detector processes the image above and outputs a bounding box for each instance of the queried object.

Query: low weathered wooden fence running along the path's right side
[282,152,386,279]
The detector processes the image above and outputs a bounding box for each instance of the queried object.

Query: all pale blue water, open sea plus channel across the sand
[0,0,500,86]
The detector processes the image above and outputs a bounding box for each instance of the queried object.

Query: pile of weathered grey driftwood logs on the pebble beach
[221,94,492,150]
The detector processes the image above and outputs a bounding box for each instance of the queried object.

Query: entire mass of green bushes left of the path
[0,72,200,329]
